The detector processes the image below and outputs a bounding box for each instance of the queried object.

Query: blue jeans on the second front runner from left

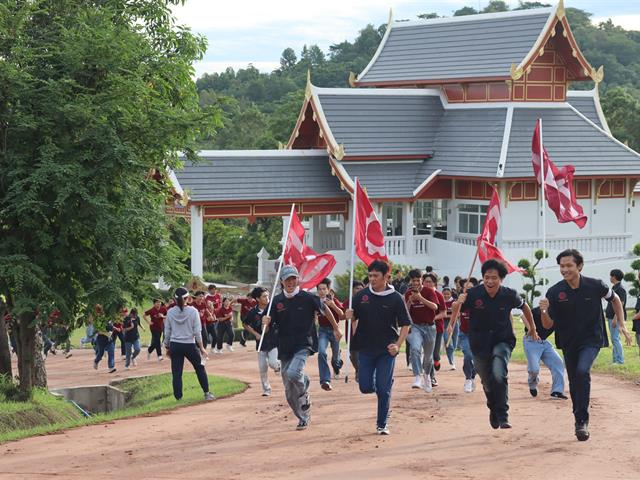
[358,352,396,428]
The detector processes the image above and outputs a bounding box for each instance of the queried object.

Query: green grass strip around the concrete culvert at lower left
[0,372,247,443]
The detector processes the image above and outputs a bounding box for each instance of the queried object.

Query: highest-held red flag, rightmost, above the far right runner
[531,120,587,228]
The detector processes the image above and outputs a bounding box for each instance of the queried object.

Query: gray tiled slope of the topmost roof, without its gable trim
[358,8,553,82]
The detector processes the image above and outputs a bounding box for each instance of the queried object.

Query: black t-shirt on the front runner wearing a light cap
[271,290,324,359]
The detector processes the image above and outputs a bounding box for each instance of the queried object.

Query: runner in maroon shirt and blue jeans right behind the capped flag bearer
[317,278,344,391]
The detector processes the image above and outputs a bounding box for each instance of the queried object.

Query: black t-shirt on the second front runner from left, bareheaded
[351,287,411,353]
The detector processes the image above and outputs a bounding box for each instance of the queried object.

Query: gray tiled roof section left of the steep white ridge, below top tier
[424,107,507,178]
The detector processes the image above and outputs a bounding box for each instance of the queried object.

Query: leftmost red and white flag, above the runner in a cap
[284,210,336,290]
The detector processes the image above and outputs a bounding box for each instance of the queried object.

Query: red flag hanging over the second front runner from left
[354,180,389,265]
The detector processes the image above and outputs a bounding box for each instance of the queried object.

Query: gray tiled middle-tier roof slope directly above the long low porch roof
[316,88,442,156]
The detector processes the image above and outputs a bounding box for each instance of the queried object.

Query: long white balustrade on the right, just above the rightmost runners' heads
[502,234,631,253]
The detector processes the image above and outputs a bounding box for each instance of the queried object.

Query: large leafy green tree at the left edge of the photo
[0,0,219,392]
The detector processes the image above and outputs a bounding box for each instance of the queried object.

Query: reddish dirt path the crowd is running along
[0,344,640,480]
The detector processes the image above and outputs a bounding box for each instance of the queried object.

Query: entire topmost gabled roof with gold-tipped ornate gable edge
[352,1,602,86]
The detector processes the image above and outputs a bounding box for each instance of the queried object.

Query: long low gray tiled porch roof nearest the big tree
[175,150,347,202]
